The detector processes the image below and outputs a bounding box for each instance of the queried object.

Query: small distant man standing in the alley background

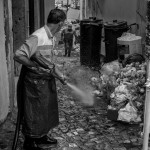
[61,24,76,57]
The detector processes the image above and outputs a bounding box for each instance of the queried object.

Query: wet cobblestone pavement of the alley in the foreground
[0,51,142,150]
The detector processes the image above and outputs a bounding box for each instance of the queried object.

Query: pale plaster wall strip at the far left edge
[0,1,10,122]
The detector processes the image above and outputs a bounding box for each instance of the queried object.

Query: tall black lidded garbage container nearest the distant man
[80,17,102,67]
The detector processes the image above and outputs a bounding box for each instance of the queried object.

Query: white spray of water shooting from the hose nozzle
[67,83,94,106]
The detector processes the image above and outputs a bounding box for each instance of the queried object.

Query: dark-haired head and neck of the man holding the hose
[47,9,66,32]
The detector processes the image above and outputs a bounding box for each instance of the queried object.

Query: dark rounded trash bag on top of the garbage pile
[122,53,145,67]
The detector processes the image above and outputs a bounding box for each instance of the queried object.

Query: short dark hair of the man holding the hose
[47,9,66,24]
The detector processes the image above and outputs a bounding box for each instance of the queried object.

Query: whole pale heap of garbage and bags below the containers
[91,59,146,123]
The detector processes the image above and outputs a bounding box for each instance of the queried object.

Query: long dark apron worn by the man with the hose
[18,66,59,138]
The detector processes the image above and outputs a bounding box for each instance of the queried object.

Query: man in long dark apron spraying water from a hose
[14,9,66,150]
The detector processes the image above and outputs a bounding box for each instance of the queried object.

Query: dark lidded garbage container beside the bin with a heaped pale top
[104,20,129,62]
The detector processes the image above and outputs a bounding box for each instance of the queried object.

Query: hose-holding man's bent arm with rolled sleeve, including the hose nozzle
[14,35,65,84]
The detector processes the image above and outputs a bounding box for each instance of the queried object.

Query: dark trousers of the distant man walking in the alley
[64,39,73,57]
